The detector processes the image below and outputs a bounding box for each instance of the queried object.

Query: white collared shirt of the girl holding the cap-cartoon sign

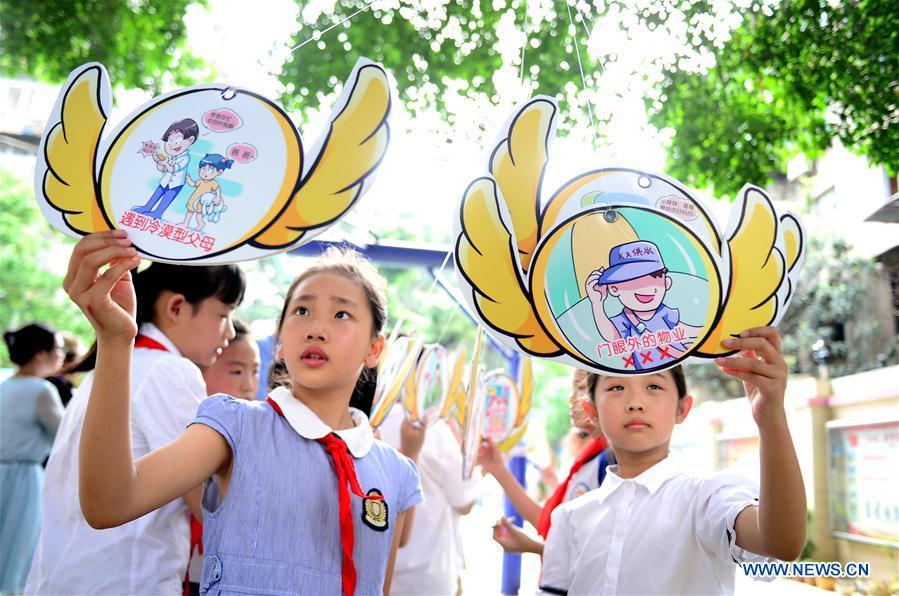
[540,456,774,595]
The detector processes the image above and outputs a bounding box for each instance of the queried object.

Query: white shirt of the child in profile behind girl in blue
[25,325,206,594]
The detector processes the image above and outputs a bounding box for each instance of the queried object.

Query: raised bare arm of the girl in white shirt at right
[715,327,807,561]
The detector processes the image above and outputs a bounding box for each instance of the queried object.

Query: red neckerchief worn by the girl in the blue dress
[266,397,383,596]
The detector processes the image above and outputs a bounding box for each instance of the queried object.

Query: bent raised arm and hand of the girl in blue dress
[63,230,230,528]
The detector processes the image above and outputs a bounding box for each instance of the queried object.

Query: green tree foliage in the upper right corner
[649,0,899,196]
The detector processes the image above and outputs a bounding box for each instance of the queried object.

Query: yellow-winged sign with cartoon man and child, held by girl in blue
[34,59,391,264]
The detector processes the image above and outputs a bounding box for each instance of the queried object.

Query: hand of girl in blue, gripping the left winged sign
[62,230,140,342]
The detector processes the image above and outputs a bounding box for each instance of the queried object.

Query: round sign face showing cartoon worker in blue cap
[530,205,722,374]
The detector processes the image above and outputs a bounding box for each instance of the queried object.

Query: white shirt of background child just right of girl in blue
[380,406,480,596]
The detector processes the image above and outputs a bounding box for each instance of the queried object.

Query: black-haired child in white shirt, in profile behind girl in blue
[25,243,244,594]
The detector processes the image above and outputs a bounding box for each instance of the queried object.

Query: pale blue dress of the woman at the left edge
[0,376,62,593]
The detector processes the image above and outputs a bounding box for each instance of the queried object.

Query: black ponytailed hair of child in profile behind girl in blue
[71,263,246,372]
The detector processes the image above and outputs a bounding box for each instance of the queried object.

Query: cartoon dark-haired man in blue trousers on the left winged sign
[131,118,200,219]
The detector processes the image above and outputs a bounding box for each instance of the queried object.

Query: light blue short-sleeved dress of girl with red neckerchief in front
[195,395,422,595]
